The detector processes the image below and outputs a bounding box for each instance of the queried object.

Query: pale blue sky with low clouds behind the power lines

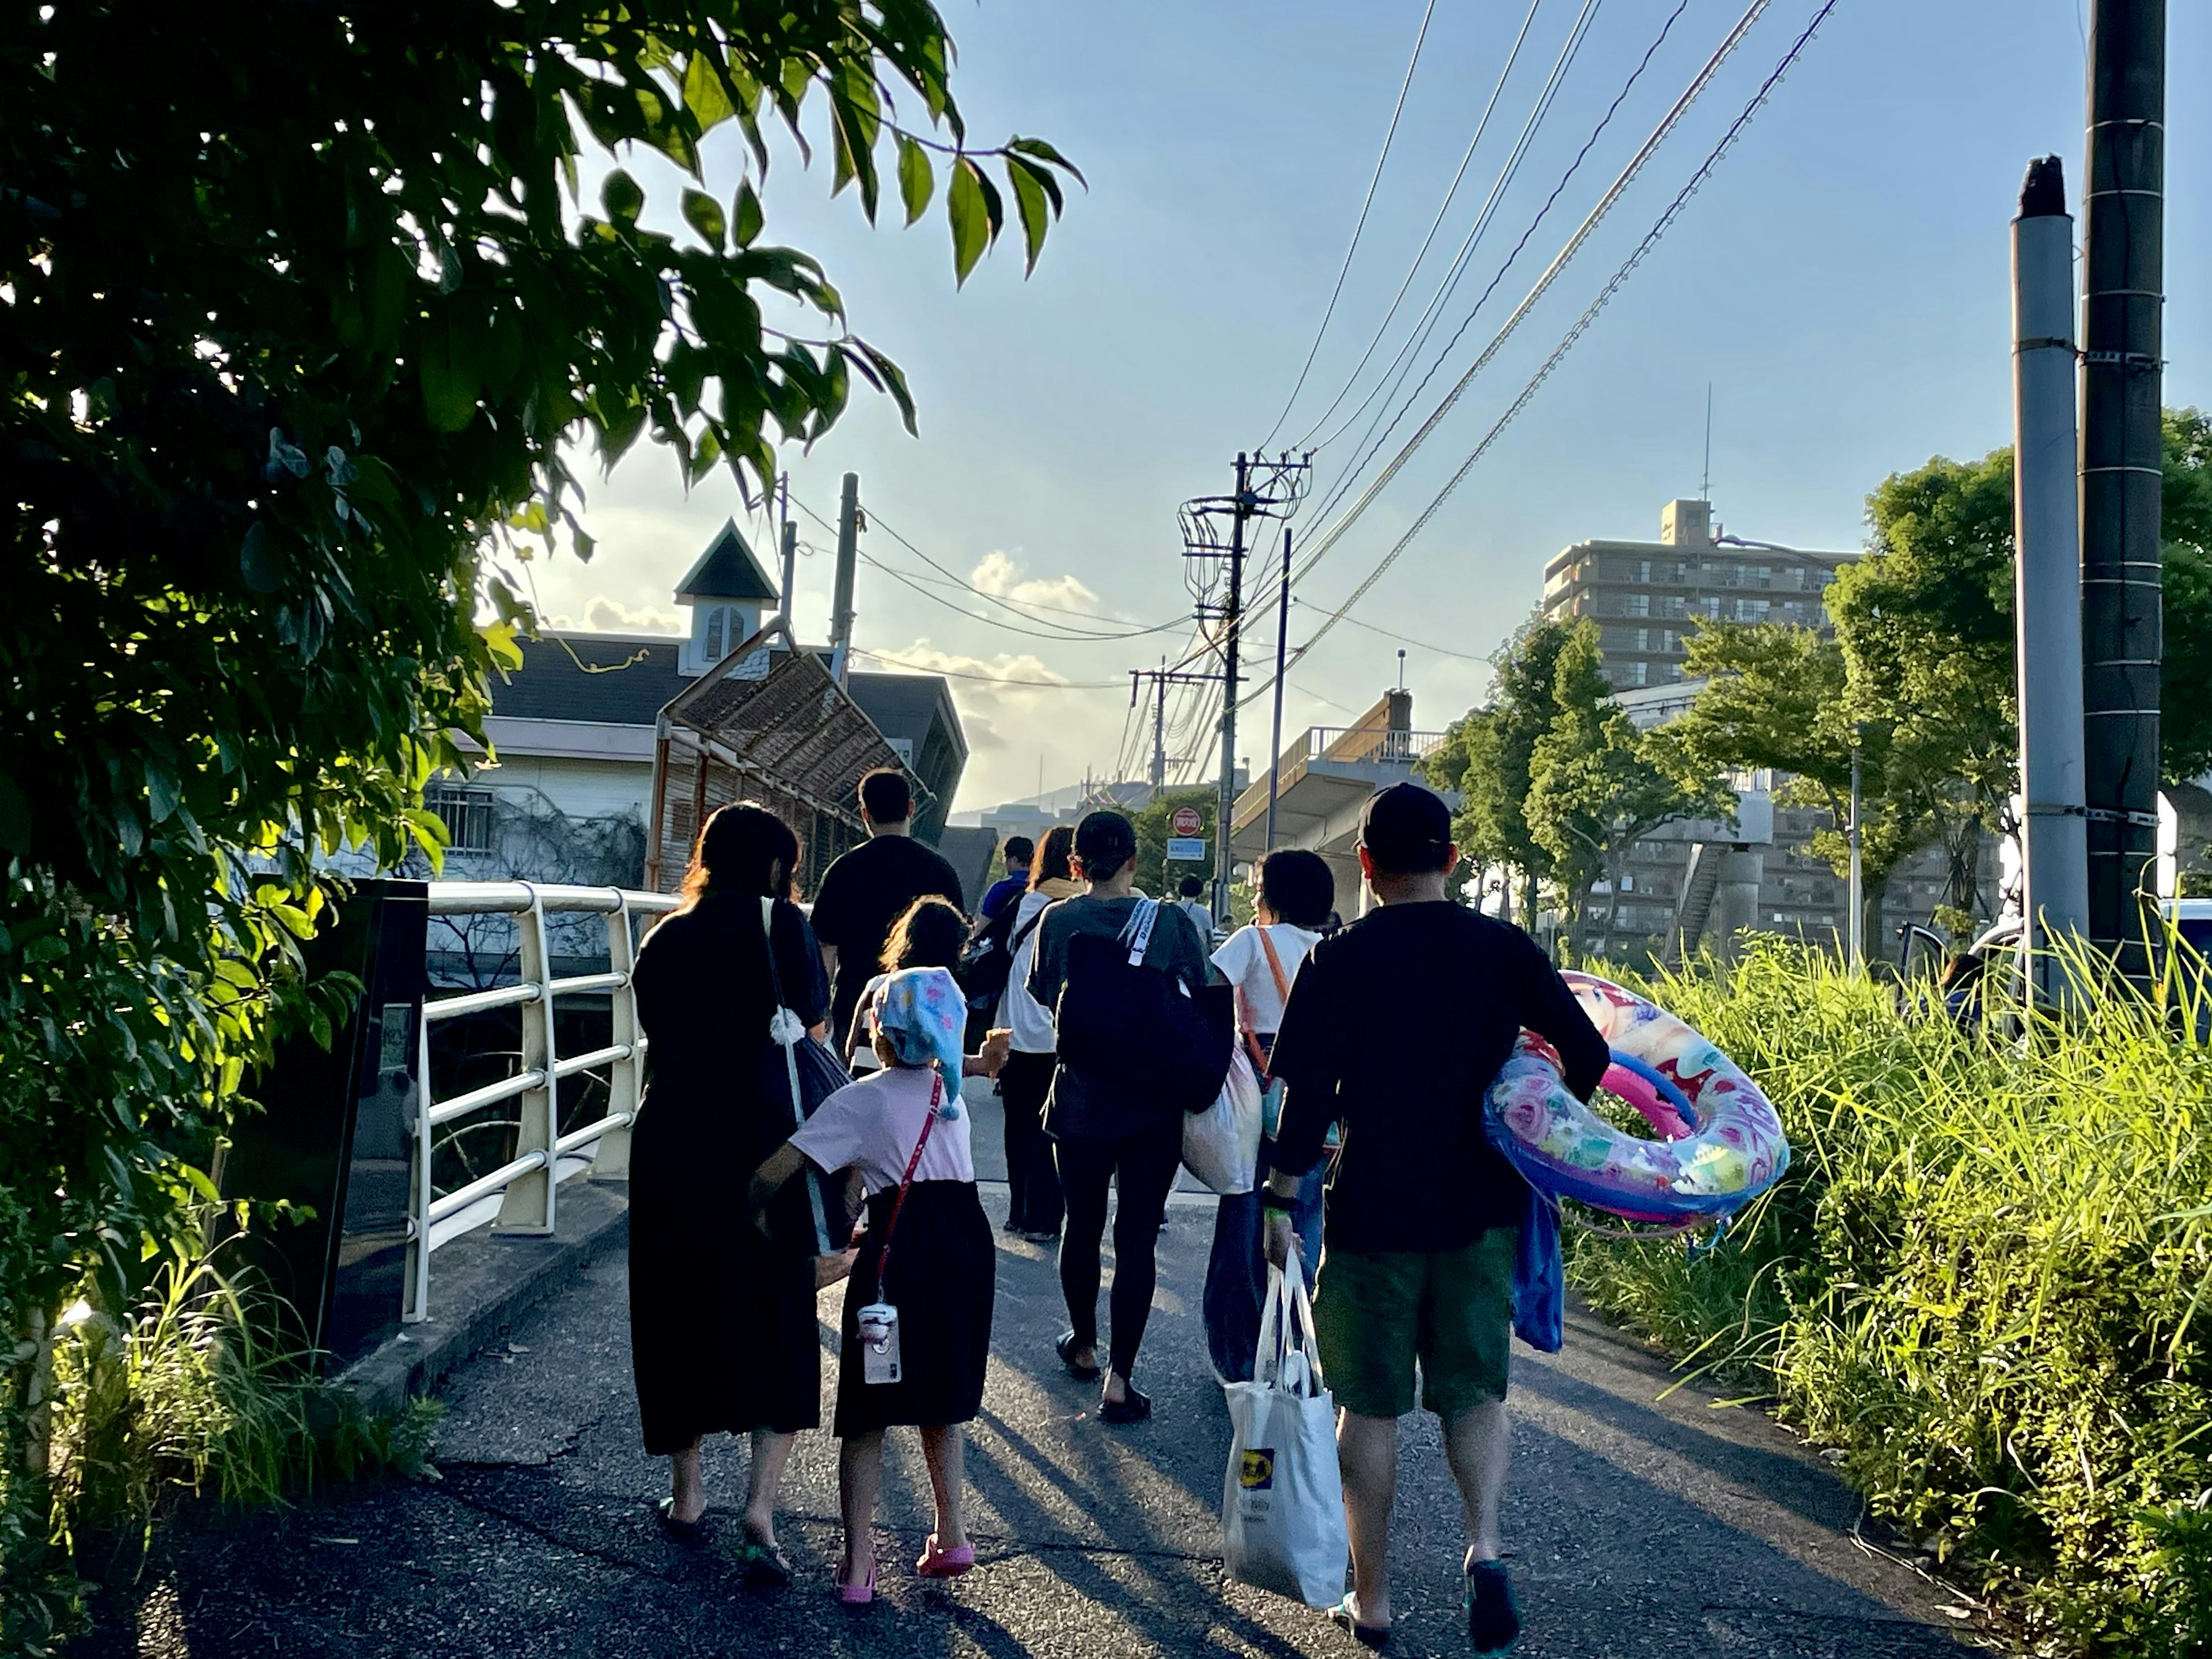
[535,0,2212,808]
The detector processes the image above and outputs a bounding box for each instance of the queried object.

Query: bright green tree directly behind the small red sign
[1522,617,1736,956]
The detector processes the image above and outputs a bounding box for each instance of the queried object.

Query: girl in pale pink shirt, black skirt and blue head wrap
[750,967,998,1606]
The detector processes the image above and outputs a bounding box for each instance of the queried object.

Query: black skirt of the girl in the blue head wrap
[836,1181,998,1438]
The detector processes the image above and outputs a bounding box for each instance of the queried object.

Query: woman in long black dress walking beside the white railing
[630,805,830,1582]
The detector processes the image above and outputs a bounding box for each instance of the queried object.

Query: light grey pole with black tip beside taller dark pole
[2013,155,2088,998]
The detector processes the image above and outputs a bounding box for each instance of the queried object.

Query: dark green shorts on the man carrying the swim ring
[1314,1228,1520,1418]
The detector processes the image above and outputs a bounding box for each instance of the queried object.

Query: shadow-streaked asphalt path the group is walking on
[79,1097,1962,1659]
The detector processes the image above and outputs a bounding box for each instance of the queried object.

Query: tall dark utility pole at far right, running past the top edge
[2081,0,2165,980]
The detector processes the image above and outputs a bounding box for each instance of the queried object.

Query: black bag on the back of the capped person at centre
[1055,898,1234,1113]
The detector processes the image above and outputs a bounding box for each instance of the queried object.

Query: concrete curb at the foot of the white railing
[339,1179,630,1416]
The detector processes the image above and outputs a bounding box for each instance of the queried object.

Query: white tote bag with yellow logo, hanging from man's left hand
[1221,1254,1351,1608]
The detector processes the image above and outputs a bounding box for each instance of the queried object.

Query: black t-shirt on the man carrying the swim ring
[1272,903,1608,1250]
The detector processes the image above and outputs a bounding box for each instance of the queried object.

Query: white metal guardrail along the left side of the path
[403,880,677,1323]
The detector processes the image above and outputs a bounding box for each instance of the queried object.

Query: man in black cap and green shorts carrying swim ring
[1263,783,1608,1652]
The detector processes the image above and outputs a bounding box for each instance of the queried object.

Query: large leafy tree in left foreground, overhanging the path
[0,0,1073,1646]
